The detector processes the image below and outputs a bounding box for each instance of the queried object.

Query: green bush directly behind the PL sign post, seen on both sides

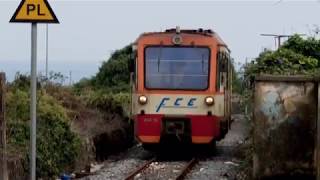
[6,89,81,177]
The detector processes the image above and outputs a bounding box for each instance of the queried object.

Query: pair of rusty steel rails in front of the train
[125,157,198,180]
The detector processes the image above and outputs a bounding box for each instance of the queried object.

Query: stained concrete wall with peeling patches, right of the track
[253,76,318,178]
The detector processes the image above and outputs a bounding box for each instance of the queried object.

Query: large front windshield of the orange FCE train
[145,46,210,90]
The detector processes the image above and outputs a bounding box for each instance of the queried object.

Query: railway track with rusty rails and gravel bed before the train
[82,117,245,180]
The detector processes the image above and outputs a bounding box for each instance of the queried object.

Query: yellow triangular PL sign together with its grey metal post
[10,0,59,180]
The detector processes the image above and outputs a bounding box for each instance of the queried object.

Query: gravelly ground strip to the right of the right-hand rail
[187,114,248,180]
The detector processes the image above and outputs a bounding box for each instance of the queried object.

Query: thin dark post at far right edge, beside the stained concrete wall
[315,82,320,180]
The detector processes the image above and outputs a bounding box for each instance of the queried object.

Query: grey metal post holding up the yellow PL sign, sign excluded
[30,23,37,180]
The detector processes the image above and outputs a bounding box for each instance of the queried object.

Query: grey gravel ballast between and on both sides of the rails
[82,115,247,180]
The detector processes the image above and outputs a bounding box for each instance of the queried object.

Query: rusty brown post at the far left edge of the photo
[0,73,8,180]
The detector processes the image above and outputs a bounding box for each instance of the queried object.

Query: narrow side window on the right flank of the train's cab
[216,51,230,92]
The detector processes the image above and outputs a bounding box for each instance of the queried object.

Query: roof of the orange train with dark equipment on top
[138,27,228,48]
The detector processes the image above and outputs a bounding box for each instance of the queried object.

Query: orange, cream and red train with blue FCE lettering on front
[129,27,232,149]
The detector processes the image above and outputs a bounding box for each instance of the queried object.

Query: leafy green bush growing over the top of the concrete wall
[244,35,320,84]
